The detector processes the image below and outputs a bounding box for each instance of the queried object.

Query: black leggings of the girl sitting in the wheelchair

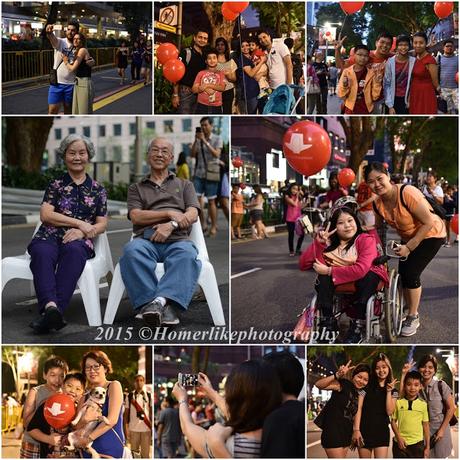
[315,272,380,319]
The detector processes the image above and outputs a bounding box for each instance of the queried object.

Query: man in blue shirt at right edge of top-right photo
[437,40,458,114]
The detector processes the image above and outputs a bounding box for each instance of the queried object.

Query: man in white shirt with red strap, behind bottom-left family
[123,374,152,458]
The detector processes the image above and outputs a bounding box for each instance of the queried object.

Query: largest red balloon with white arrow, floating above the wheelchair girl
[283,120,331,176]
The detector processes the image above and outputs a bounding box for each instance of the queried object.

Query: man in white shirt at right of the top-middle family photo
[258,30,293,89]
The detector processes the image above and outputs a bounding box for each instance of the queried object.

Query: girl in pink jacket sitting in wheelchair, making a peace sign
[299,206,389,343]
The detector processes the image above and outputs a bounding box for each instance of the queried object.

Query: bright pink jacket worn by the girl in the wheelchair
[299,233,389,286]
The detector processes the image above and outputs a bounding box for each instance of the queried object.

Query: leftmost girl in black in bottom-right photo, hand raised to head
[315,361,370,458]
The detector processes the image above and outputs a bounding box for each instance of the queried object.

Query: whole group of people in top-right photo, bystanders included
[307,32,458,115]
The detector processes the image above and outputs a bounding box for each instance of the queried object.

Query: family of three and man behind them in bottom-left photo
[15,350,152,458]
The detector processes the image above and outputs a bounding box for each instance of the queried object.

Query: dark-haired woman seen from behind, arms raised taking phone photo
[173,360,281,458]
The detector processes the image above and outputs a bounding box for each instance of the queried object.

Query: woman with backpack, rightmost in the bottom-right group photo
[400,355,456,458]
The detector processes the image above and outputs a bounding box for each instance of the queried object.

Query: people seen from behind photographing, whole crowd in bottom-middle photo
[155,351,305,458]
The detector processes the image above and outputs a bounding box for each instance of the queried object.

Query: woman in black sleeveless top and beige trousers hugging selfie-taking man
[62,33,94,115]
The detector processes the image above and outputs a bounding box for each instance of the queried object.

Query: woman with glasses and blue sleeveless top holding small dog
[76,351,125,458]
